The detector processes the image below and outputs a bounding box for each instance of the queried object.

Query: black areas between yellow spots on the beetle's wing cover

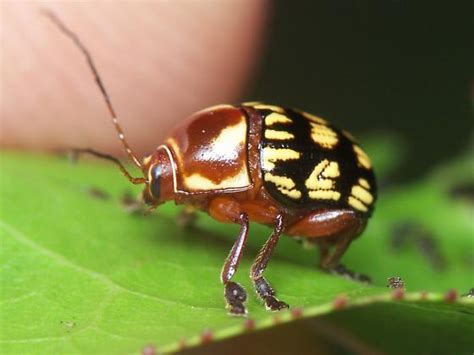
[257,105,377,216]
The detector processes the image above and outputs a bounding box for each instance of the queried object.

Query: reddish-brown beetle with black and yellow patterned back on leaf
[47,13,377,315]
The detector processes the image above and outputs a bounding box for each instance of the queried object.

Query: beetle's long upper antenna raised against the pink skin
[44,10,142,171]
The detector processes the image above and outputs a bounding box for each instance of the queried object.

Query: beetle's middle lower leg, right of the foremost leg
[250,215,289,311]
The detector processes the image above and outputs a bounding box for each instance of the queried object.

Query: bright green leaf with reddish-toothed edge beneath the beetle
[0,152,474,354]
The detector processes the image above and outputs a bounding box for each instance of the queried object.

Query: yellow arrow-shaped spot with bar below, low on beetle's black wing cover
[305,159,341,201]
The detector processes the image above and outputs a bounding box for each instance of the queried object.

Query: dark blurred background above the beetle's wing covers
[246,0,474,180]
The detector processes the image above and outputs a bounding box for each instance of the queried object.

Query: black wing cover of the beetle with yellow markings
[244,104,376,214]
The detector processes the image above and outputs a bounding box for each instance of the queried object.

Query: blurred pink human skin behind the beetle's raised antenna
[0,0,268,156]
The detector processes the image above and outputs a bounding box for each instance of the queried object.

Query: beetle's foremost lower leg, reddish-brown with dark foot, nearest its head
[221,213,249,316]
